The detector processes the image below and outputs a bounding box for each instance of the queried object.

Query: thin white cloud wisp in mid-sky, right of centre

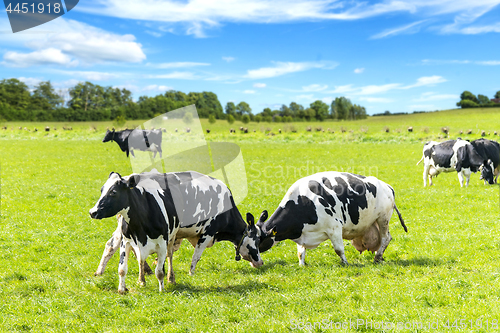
[244,61,337,79]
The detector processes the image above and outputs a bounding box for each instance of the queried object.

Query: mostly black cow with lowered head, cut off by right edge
[471,139,500,184]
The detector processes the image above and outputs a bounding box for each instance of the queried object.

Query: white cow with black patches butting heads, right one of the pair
[257,171,407,265]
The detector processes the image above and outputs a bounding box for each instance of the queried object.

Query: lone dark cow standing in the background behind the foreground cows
[102,129,162,158]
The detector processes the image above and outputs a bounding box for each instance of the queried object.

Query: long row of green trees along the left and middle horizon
[0,78,367,123]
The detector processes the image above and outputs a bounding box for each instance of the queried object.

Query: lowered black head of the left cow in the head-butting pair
[235,213,264,268]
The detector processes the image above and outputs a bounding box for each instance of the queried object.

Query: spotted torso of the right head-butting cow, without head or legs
[272,171,394,241]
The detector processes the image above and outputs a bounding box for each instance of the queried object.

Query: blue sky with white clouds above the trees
[0,0,500,114]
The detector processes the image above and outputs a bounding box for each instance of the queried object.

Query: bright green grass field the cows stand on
[0,109,500,332]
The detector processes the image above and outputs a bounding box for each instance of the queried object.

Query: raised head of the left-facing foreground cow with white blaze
[89,172,135,220]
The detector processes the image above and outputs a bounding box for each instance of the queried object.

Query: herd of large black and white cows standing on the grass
[89,131,500,293]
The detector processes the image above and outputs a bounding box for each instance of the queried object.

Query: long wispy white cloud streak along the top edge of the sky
[73,0,498,38]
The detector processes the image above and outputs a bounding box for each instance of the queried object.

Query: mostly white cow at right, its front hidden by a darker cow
[417,139,486,187]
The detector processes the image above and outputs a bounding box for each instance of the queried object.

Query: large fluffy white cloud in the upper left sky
[0,18,146,67]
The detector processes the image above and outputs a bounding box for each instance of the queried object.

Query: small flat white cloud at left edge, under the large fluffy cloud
[2,48,78,67]
